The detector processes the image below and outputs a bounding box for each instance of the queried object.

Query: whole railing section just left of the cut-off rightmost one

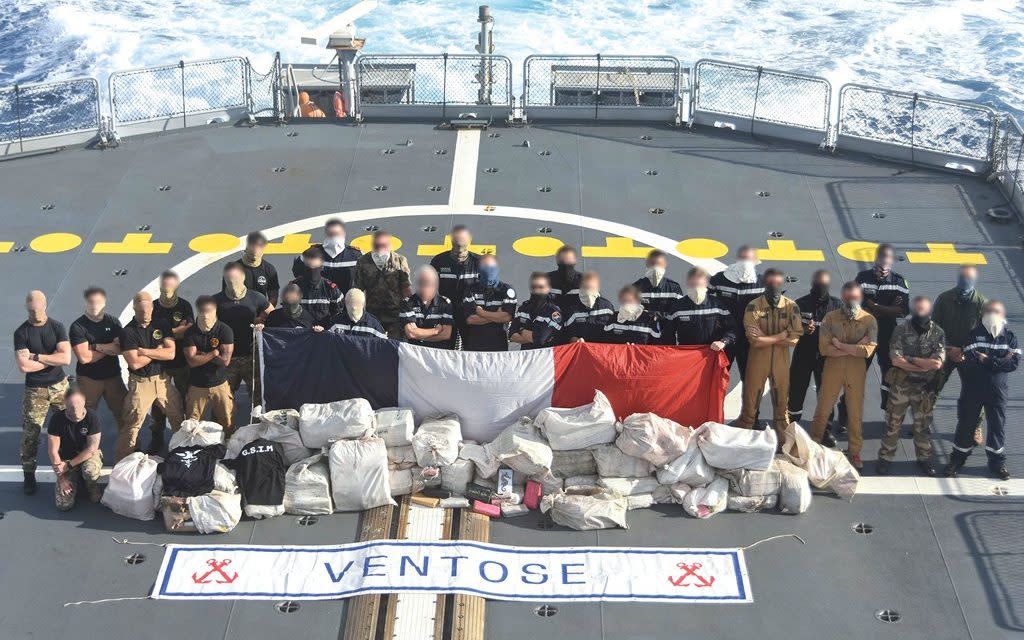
[836,84,997,174]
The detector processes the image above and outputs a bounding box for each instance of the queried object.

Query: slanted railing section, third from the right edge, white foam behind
[690,59,833,144]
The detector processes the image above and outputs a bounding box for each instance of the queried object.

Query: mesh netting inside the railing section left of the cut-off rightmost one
[839,84,995,160]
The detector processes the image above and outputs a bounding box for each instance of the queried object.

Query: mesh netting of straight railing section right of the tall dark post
[523,55,680,109]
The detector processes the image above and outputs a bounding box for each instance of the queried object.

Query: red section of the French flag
[552,342,729,427]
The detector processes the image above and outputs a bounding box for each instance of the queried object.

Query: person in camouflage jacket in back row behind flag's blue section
[352,231,413,340]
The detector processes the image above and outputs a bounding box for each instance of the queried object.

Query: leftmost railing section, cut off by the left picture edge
[0,78,100,157]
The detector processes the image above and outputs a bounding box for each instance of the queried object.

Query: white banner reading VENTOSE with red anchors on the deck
[152,541,753,604]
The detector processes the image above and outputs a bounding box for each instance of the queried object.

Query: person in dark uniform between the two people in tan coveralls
[790,269,842,438]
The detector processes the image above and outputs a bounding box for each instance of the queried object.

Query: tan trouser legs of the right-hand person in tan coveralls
[811,355,867,456]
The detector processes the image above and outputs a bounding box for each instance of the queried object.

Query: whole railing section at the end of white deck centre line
[355,53,514,122]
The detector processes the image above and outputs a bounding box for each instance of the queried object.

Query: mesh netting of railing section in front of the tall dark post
[355,53,512,111]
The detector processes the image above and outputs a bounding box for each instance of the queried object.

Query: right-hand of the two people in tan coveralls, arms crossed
[811,282,879,469]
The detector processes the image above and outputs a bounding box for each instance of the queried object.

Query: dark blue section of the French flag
[262,329,398,410]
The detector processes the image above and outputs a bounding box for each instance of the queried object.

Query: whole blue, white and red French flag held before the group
[259,329,729,442]
